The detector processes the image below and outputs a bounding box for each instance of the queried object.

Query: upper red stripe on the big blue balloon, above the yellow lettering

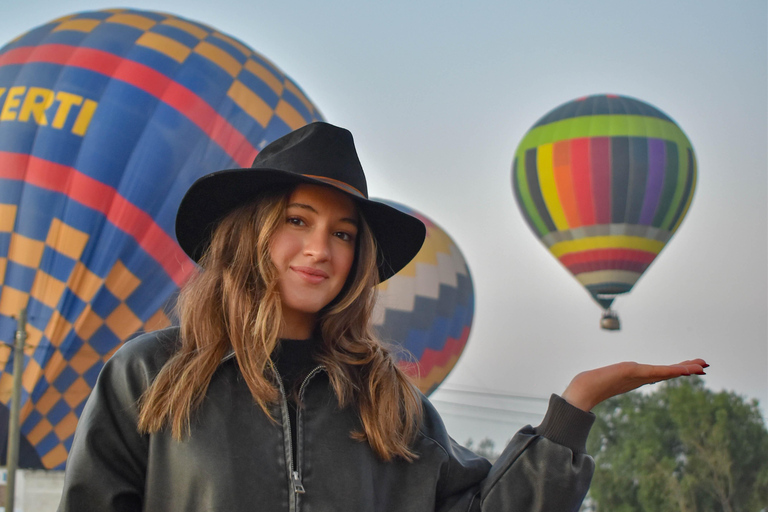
[0,44,258,167]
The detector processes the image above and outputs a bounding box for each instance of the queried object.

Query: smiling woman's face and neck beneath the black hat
[269,185,358,339]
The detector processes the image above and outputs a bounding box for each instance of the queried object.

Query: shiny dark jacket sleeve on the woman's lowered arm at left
[58,335,176,512]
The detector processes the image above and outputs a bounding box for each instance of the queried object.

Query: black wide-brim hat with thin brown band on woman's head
[176,122,426,281]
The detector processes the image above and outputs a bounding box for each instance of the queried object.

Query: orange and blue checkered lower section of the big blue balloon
[0,212,171,468]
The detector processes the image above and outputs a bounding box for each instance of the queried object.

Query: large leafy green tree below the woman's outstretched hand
[587,377,768,512]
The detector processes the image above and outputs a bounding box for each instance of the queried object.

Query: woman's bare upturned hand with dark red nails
[562,359,709,411]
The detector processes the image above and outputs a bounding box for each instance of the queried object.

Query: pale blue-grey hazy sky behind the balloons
[0,0,768,442]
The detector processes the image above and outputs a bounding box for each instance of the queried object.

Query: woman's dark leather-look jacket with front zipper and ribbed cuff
[59,328,594,512]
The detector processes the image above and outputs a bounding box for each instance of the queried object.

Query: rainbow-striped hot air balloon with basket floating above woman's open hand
[512,94,696,330]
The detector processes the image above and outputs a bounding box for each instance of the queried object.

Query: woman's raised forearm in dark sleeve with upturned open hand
[469,359,708,512]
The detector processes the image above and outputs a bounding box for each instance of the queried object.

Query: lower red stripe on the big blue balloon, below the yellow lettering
[0,151,194,286]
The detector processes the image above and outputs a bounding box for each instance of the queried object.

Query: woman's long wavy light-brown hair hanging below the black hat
[139,187,421,461]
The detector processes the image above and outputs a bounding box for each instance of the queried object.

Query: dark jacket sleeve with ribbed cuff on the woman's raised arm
[438,395,595,512]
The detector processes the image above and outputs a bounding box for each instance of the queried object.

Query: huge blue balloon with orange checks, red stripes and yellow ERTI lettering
[0,9,322,469]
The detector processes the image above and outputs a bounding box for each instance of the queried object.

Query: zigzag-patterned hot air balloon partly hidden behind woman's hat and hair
[373,199,475,394]
